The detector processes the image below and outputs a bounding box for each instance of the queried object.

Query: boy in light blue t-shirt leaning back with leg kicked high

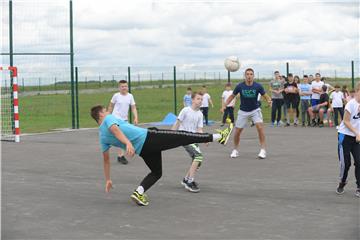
[90,105,231,206]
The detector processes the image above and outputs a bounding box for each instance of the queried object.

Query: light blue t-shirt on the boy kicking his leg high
[99,114,147,154]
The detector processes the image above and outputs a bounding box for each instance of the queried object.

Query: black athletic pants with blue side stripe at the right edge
[338,133,360,188]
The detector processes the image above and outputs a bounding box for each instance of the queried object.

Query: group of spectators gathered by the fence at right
[269,71,355,127]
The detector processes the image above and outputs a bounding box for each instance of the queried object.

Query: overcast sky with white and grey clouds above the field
[3,0,360,77]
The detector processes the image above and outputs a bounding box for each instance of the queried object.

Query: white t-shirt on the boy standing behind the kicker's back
[111,93,135,121]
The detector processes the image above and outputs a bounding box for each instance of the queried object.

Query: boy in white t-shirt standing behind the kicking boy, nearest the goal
[107,80,139,164]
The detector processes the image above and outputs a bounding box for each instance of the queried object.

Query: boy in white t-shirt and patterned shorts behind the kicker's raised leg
[171,92,210,192]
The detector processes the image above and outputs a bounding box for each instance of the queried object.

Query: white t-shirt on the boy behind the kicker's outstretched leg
[177,107,204,132]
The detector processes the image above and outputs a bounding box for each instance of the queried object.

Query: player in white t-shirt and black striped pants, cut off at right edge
[336,83,360,197]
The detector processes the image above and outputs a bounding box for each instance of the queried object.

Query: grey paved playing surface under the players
[2,124,360,239]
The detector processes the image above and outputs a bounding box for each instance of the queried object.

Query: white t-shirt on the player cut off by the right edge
[338,99,360,137]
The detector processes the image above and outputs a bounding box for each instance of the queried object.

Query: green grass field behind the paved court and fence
[16,83,269,133]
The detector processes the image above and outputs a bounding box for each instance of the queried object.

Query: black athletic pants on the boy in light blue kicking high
[140,128,213,191]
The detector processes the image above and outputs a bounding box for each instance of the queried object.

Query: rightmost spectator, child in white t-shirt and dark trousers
[327,85,345,127]
